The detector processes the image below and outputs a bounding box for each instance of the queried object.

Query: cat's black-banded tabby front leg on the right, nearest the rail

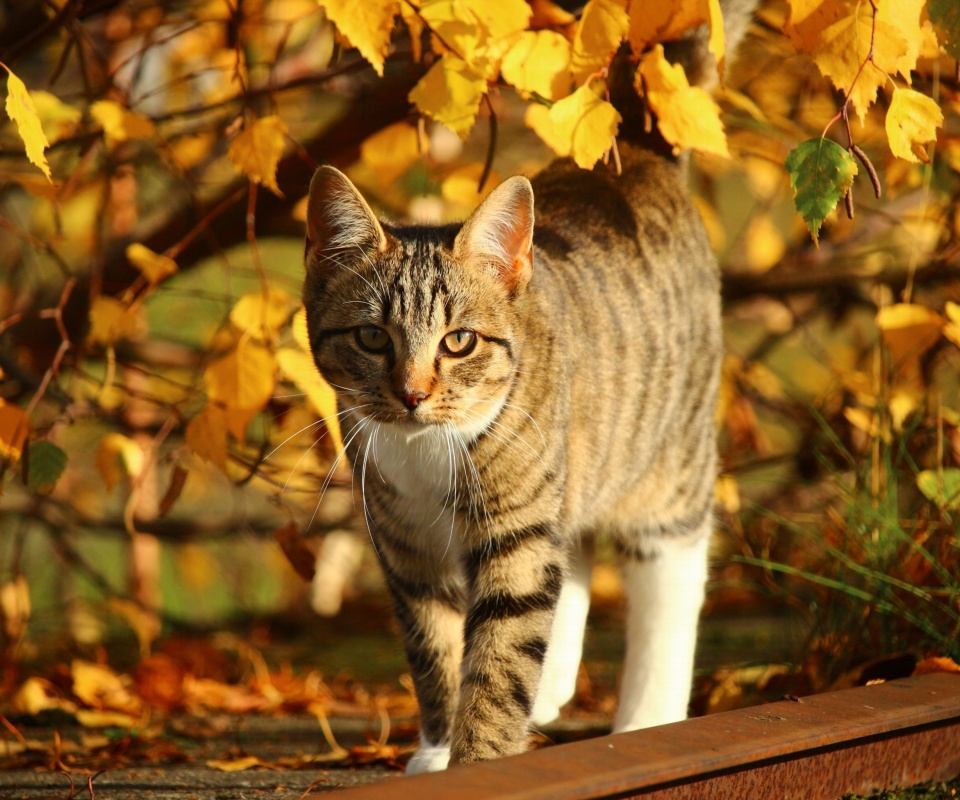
[451,524,565,764]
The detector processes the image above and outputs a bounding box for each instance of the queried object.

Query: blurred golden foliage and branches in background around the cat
[0,0,960,707]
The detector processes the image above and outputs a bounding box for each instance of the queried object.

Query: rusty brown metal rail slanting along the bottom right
[324,673,960,800]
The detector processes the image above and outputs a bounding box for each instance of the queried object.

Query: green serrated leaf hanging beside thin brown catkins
[785,139,857,242]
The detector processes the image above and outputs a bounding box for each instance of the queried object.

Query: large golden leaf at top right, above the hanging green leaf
[812,3,908,122]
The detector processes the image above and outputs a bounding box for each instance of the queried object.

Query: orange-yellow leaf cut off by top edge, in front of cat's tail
[627,0,724,72]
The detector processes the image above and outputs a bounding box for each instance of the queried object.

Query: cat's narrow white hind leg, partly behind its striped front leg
[531,541,593,725]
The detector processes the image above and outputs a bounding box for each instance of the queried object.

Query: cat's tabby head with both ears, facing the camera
[303,167,533,438]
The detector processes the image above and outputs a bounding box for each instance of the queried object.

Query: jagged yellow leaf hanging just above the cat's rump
[636,44,730,158]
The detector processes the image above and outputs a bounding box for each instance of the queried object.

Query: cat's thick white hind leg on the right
[613,518,711,733]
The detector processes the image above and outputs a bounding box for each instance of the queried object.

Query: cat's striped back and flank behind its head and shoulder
[532,144,721,532]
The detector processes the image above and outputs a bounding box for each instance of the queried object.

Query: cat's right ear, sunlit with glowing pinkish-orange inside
[453,176,533,292]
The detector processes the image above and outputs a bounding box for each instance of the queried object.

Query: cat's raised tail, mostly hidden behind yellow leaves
[610,0,759,149]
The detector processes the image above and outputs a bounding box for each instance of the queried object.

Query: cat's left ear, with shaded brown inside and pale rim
[306,166,387,269]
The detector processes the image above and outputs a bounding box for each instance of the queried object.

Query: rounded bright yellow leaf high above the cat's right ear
[500,31,571,100]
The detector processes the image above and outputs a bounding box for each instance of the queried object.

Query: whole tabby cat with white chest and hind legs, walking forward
[303,0,752,772]
